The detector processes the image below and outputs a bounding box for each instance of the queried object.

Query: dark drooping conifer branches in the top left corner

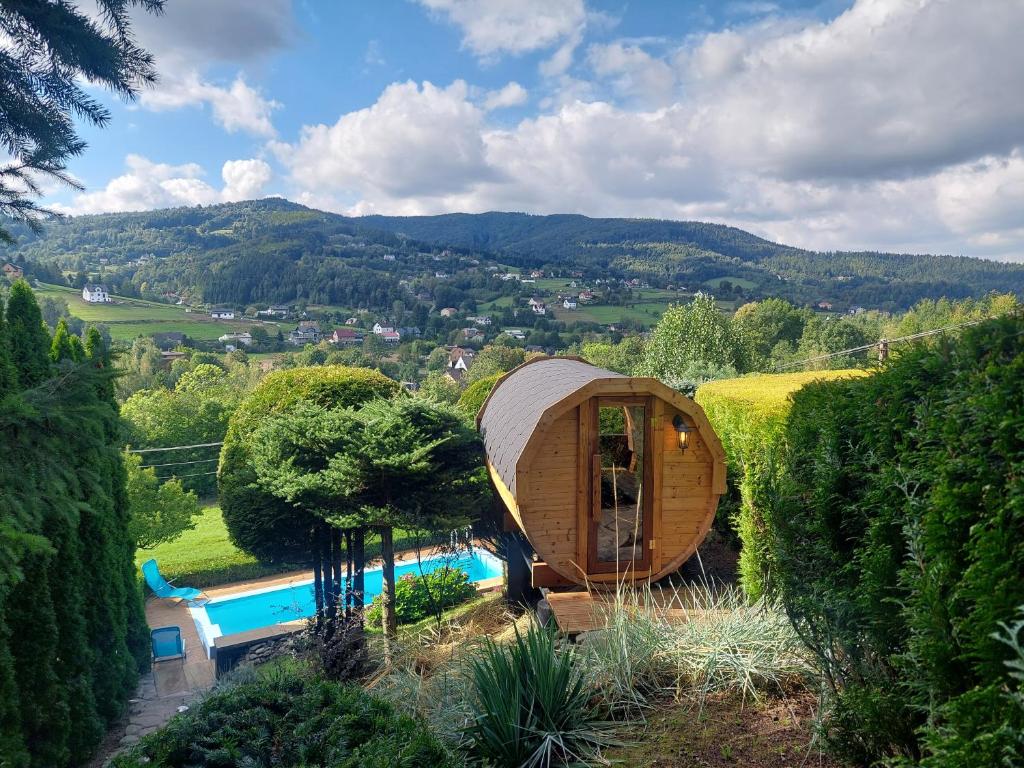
[0,0,164,242]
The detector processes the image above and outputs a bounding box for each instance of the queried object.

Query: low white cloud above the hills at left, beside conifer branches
[51,155,271,215]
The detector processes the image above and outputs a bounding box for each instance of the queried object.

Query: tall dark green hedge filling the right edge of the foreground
[767,317,1024,768]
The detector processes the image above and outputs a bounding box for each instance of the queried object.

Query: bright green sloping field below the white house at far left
[35,285,274,341]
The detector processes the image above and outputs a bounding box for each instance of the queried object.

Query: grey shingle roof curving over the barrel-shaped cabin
[476,357,627,494]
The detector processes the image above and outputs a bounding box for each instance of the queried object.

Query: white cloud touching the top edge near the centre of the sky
[419,0,587,58]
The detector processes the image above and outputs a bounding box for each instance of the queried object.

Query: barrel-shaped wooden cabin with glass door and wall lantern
[476,357,725,587]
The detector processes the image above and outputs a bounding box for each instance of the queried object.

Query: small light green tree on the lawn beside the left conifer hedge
[124,454,201,549]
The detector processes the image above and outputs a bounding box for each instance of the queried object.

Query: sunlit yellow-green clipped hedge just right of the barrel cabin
[694,370,864,600]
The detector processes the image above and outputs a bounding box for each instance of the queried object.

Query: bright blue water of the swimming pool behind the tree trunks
[200,549,502,641]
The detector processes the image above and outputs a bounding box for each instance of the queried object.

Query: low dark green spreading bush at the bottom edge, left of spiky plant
[113,663,455,768]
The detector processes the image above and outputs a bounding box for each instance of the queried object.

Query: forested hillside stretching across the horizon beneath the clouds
[0,199,1024,310]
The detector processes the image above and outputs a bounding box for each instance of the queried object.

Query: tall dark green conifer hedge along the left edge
[0,281,150,768]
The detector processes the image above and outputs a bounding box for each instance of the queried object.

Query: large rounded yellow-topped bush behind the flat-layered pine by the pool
[217,366,400,563]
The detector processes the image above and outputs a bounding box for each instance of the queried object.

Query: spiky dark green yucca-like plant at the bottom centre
[468,626,611,768]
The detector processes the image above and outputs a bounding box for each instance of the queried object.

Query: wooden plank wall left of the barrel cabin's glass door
[519,409,579,573]
